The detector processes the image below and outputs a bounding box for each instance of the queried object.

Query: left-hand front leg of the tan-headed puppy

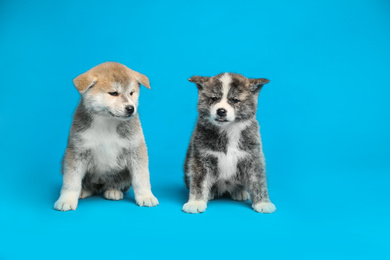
[54,149,86,211]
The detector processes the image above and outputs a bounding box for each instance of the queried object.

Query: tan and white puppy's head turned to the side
[73,62,150,120]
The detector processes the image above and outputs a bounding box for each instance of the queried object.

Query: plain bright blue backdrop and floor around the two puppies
[0,0,390,259]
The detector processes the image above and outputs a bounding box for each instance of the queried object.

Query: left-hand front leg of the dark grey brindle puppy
[183,153,213,213]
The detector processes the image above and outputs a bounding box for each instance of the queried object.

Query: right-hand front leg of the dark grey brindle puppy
[246,156,276,213]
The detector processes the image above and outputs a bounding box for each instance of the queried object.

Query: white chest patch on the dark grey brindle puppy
[207,122,250,180]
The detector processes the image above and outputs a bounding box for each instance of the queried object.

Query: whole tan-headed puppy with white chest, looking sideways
[54,62,158,211]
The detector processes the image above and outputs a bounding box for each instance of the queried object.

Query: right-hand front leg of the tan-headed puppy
[128,143,158,207]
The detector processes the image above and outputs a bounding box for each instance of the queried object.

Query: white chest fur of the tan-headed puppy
[81,117,136,174]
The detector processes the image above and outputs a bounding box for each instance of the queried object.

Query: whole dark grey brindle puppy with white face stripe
[183,73,276,213]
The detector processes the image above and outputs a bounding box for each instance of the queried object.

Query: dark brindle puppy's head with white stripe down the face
[189,73,269,126]
